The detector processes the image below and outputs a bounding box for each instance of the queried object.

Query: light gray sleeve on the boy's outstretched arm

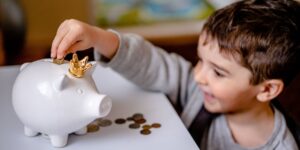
[95,30,196,112]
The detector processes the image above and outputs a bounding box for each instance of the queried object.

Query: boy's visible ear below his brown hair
[256,79,284,102]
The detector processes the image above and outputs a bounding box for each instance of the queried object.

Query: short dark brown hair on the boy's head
[202,0,300,84]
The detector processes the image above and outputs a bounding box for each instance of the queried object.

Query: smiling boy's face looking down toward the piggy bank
[195,36,259,113]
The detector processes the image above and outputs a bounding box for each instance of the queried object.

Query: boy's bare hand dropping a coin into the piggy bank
[51,19,119,59]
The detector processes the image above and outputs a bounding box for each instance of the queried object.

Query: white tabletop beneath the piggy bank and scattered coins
[0,66,199,150]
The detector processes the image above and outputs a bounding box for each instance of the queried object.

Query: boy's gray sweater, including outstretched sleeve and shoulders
[95,31,298,150]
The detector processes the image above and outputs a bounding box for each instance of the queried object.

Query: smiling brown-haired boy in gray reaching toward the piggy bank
[51,0,300,150]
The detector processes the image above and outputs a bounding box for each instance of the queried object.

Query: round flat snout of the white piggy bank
[98,95,112,117]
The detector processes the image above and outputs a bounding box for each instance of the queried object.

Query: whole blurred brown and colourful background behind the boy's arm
[0,0,237,65]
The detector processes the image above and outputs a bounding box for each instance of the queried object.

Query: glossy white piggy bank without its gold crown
[12,59,112,147]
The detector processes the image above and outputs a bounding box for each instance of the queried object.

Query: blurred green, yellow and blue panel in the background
[94,0,214,27]
